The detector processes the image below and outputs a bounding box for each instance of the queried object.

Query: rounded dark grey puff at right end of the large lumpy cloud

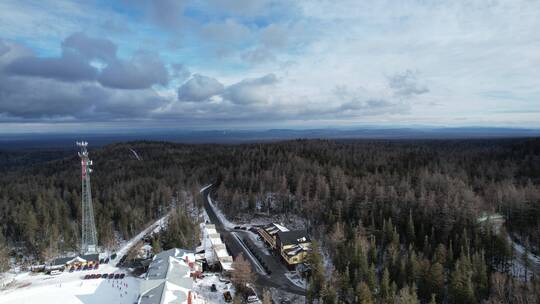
[98,53,169,90]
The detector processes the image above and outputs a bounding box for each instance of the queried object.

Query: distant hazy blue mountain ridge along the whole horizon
[0,127,540,149]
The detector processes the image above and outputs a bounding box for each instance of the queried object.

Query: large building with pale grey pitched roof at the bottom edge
[137,248,201,304]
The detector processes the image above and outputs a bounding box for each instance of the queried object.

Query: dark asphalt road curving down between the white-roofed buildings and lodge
[202,187,306,296]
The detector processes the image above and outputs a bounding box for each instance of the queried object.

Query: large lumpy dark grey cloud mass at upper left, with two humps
[5,33,169,90]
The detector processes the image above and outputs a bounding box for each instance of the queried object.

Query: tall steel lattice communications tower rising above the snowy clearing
[77,141,97,254]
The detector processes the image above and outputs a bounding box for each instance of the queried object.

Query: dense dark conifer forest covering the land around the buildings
[0,138,540,303]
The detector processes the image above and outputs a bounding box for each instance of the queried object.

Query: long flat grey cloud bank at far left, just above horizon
[0,75,166,120]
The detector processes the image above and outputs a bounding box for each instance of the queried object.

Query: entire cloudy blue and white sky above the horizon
[0,0,540,133]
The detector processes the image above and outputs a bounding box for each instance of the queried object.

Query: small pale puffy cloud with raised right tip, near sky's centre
[223,74,278,105]
